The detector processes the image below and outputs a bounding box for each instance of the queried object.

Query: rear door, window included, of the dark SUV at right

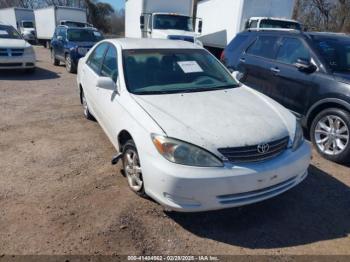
[238,35,279,95]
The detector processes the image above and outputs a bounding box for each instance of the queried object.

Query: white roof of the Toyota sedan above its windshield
[108,38,203,50]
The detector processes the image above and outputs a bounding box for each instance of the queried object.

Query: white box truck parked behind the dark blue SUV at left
[34,6,87,47]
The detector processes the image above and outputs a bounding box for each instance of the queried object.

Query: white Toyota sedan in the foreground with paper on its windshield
[77,39,311,212]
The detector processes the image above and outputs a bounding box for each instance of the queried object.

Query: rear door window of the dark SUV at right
[247,36,278,59]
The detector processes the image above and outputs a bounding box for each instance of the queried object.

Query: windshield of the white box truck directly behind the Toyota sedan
[153,15,193,32]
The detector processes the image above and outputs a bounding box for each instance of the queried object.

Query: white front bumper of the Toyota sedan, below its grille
[142,142,311,212]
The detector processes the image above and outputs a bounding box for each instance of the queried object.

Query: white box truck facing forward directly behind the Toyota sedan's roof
[125,0,201,42]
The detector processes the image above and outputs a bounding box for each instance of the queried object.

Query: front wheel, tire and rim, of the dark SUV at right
[310,108,350,164]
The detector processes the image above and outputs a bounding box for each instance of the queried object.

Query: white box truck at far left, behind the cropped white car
[0,8,36,42]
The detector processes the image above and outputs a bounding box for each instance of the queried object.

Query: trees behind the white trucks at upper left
[0,0,124,35]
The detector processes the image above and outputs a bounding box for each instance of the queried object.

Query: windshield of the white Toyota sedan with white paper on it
[123,49,238,95]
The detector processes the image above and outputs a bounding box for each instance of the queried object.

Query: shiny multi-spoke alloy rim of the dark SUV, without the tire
[315,115,350,156]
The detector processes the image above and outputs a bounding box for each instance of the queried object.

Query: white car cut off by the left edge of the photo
[0,23,36,72]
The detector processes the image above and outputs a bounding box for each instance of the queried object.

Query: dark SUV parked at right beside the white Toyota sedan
[222,30,350,163]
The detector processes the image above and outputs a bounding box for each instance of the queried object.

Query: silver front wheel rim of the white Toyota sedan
[124,150,143,192]
